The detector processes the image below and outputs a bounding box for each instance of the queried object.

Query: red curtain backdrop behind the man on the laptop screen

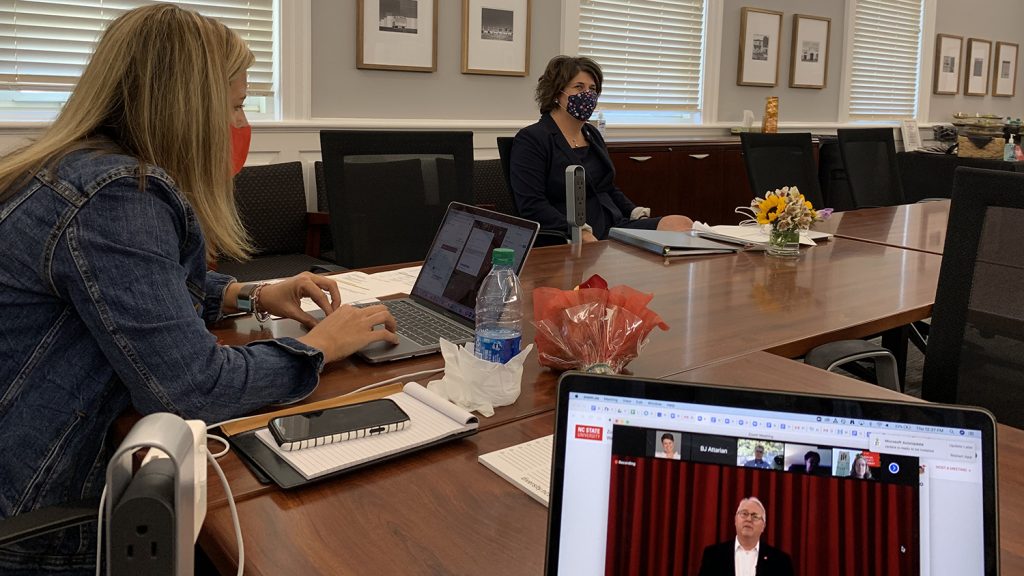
[605,456,921,576]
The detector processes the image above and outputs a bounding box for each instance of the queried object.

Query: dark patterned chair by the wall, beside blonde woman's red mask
[217,162,343,282]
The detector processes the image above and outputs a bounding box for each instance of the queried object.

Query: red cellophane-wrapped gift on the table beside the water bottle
[534,275,669,373]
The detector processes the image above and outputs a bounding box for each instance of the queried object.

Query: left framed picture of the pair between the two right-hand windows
[736,6,782,86]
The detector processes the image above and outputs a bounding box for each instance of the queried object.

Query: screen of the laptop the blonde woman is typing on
[412,202,539,321]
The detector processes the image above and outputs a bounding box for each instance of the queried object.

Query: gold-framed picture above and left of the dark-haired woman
[462,0,532,76]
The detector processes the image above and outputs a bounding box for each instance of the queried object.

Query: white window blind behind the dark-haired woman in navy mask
[580,0,705,110]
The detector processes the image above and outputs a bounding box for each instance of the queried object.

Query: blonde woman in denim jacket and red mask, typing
[0,4,397,574]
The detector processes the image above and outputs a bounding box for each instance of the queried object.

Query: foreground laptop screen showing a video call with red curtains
[547,374,998,575]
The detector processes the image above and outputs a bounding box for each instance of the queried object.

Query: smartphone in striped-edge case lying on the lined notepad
[268,398,410,450]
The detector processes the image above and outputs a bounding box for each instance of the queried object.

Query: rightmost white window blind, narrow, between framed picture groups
[849,0,924,120]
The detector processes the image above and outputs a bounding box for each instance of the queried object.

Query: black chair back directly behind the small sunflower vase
[739,132,824,208]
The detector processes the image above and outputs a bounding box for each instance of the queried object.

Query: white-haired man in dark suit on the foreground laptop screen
[698,496,793,576]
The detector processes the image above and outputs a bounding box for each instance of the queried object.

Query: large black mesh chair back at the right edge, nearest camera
[922,168,1024,427]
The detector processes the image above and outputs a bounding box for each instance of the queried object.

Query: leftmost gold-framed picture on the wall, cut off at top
[355,0,438,72]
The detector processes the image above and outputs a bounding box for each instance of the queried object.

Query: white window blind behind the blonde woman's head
[0,0,274,96]
